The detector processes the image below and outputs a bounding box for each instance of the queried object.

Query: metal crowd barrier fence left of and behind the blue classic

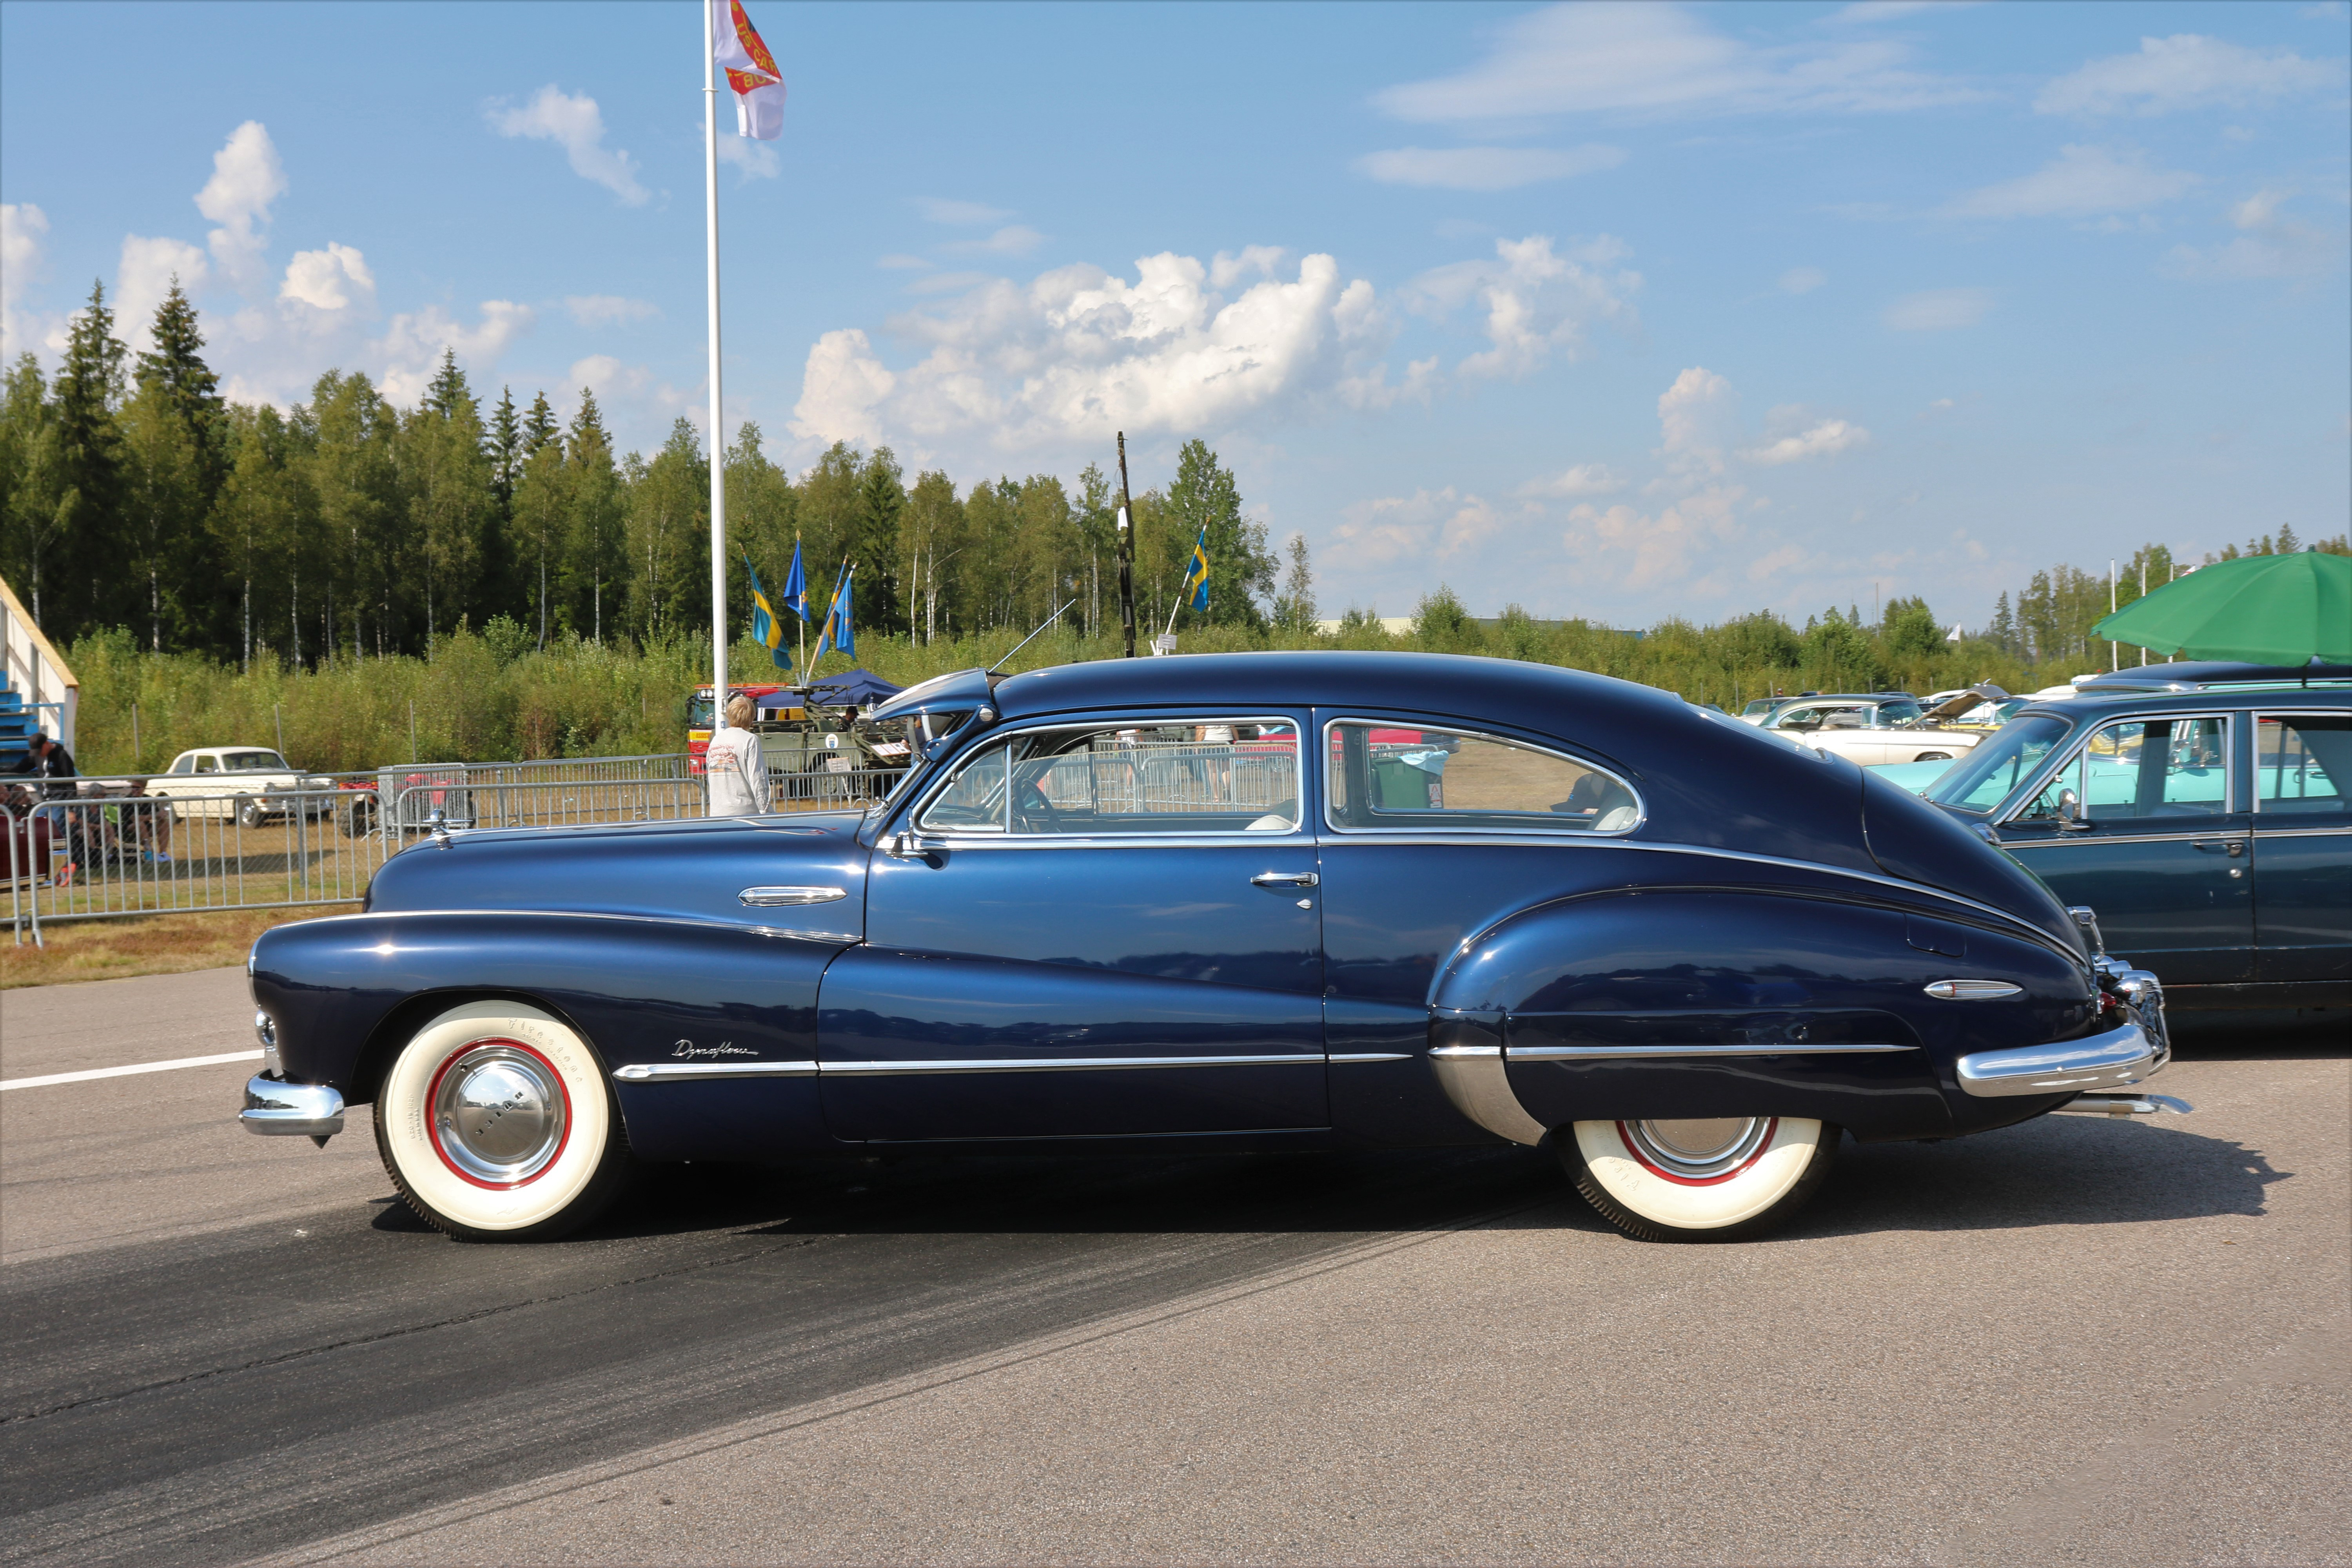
[0,755,901,943]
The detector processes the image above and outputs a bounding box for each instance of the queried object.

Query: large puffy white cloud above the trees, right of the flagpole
[793,252,1378,451]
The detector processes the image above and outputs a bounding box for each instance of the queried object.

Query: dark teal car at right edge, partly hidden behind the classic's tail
[1926,663,2352,1006]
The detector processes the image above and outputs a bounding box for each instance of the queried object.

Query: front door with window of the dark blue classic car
[818,712,1329,1140]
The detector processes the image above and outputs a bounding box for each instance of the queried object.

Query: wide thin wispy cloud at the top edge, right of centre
[1376,0,1978,122]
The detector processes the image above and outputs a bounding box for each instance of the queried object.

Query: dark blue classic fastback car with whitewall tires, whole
[245,653,2185,1239]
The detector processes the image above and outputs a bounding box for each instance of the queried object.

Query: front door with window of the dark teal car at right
[1999,715,2253,985]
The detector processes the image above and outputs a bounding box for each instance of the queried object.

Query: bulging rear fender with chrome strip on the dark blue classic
[1432,889,2098,1140]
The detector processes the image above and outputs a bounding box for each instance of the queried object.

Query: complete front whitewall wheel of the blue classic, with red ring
[376,1002,630,1241]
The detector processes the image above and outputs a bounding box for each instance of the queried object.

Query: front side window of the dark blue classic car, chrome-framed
[915,717,1298,837]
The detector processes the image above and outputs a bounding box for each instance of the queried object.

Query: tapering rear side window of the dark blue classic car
[1327,719,1642,832]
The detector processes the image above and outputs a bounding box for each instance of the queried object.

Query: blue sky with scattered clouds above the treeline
[0,0,2352,625]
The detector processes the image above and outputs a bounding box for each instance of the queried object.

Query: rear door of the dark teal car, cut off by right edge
[2253,710,2352,980]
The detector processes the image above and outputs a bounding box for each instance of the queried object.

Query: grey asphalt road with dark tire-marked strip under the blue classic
[0,971,2352,1566]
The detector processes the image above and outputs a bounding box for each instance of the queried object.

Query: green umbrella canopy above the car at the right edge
[2091,550,2352,665]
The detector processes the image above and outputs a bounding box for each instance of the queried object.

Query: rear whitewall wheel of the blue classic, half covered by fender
[1552,1117,1844,1241]
